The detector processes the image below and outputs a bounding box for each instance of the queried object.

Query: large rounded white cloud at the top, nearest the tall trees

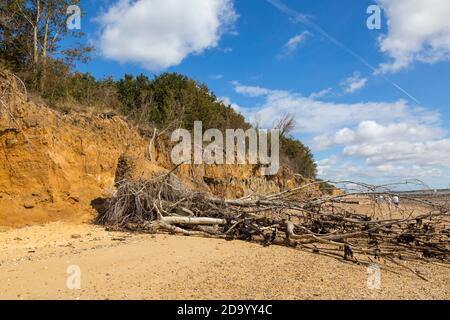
[98,0,237,70]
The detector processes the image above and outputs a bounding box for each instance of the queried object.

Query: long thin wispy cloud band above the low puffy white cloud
[233,81,440,135]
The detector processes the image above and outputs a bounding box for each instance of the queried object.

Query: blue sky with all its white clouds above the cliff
[69,0,450,188]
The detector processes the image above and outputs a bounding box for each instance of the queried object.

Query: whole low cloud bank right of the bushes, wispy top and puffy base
[234,82,450,186]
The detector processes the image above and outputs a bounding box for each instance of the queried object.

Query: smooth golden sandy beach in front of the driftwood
[0,222,450,299]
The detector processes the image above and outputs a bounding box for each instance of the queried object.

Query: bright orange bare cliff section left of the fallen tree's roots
[0,73,150,226]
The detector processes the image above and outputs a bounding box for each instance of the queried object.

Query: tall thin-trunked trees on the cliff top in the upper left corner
[0,0,92,93]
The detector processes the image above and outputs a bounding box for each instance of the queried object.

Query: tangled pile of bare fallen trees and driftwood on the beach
[98,174,450,263]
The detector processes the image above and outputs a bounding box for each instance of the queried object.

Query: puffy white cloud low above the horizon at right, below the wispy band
[315,121,450,184]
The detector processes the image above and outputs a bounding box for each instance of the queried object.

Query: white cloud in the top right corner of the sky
[377,0,450,72]
